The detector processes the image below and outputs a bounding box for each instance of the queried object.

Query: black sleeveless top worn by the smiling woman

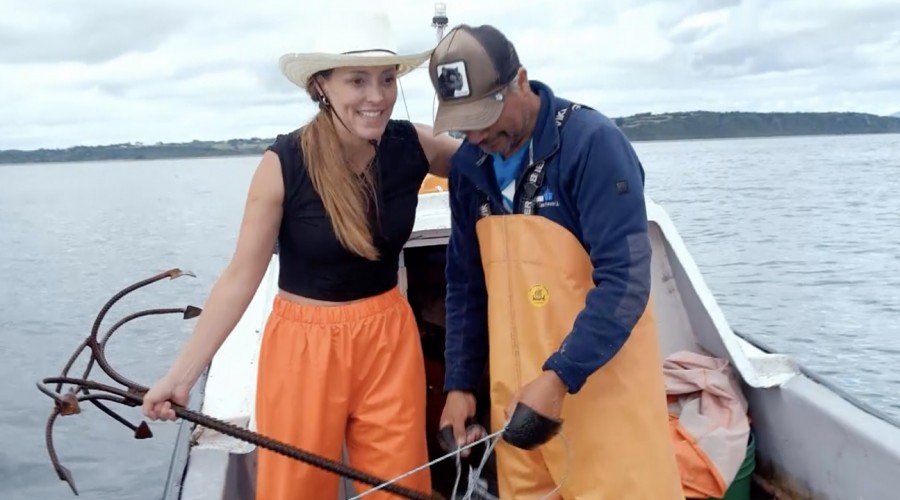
[267,120,429,301]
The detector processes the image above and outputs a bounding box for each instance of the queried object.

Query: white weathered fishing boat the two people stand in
[163,3,900,500]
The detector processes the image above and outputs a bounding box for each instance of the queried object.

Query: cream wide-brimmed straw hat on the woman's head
[278,10,432,90]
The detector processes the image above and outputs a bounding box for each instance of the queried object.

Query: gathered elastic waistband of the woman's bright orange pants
[272,287,405,324]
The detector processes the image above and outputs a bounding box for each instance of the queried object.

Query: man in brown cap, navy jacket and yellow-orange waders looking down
[429,25,683,500]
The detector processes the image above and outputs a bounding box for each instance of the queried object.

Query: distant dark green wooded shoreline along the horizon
[0,111,900,164]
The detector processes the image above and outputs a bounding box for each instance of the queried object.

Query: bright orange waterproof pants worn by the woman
[256,288,431,500]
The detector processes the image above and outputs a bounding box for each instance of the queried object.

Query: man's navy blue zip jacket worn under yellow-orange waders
[444,81,650,393]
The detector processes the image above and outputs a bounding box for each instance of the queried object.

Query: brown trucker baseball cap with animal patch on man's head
[428,24,520,135]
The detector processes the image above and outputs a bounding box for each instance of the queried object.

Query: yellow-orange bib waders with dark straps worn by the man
[476,103,684,500]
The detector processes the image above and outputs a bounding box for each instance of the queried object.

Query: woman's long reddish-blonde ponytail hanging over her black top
[300,71,379,260]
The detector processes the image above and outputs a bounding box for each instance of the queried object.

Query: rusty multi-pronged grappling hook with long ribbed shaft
[37,269,443,500]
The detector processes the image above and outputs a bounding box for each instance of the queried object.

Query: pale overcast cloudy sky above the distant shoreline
[0,0,900,149]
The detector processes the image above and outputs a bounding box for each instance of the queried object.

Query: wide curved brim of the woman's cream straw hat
[278,50,431,90]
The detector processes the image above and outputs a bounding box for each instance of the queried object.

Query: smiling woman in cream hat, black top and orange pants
[143,14,459,500]
